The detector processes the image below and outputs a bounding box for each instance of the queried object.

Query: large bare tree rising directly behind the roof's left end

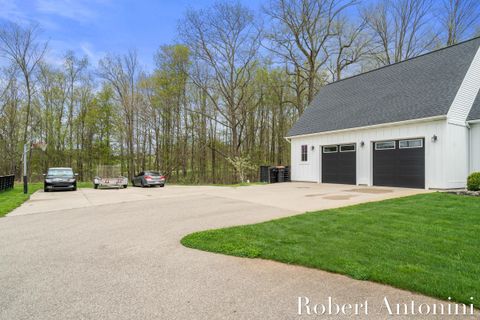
[265,0,356,109]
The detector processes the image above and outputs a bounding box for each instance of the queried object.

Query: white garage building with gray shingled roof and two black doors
[287,37,480,189]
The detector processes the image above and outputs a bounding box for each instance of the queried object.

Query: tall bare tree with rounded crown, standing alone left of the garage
[180,2,262,162]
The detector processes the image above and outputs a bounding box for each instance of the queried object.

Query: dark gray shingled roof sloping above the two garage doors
[288,38,480,137]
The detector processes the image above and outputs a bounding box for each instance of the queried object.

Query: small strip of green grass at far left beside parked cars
[0,182,93,218]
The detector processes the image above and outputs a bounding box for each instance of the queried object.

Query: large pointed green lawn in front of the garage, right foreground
[181,193,480,307]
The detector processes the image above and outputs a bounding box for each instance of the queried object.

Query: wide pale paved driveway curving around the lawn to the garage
[0,183,465,319]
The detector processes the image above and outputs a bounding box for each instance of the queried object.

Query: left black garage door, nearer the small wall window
[322,144,357,184]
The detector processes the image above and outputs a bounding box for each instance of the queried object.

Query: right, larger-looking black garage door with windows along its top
[373,138,425,188]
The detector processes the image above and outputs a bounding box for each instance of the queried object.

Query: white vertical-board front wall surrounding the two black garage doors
[291,119,448,189]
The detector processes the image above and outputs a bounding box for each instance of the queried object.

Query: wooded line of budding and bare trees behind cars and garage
[0,0,480,183]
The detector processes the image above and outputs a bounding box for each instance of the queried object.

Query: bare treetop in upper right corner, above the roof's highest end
[442,0,480,45]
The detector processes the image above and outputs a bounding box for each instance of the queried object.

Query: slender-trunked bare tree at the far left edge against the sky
[0,23,47,143]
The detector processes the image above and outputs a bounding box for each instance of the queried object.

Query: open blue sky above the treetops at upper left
[0,0,263,71]
